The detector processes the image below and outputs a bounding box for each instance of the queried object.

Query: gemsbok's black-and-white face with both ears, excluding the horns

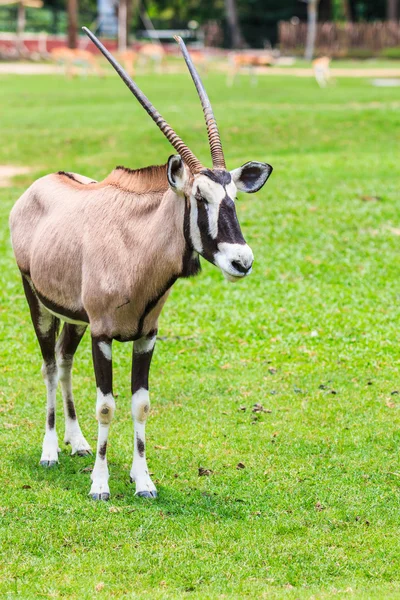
[168,156,272,282]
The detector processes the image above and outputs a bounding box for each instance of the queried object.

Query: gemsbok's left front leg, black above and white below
[89,336,115,500]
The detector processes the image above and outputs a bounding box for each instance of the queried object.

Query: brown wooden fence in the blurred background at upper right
[279,21,400,57]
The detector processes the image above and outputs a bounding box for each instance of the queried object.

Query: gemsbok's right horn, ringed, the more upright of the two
[175,35,226,169]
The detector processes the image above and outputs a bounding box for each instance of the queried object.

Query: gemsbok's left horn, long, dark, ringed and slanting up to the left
[82,27,204,173]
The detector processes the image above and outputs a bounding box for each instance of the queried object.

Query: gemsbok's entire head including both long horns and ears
[83,27,272,281]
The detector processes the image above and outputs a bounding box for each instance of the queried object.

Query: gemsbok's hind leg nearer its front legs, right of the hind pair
[56,323,92,456]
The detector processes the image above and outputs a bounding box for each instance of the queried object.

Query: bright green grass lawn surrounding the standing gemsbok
[0,75,400,600]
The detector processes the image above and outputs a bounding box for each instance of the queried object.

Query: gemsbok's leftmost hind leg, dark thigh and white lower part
[22,277,60,467]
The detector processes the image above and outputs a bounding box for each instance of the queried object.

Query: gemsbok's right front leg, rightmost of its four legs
[131,331,157,498]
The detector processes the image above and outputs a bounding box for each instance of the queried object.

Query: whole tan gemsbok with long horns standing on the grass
[10,28,272,500]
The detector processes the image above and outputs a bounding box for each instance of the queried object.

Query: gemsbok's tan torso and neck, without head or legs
[10,167,185,339]
